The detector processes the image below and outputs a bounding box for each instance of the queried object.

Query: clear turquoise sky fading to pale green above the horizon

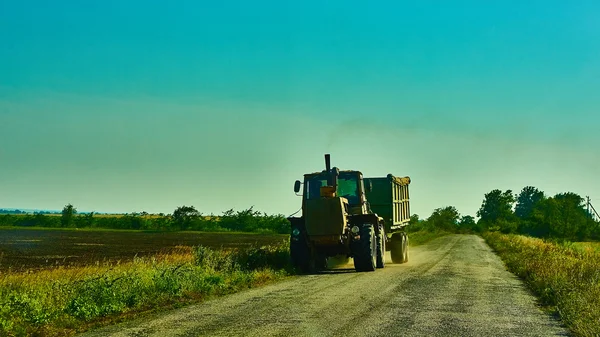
[0,0,600,218]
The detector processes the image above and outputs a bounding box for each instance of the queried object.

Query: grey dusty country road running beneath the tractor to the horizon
[78,235,568,337]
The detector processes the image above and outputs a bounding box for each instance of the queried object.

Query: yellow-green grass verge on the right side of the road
[482,232,600,336]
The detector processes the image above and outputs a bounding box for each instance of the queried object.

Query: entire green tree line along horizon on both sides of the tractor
[0,186,600,241]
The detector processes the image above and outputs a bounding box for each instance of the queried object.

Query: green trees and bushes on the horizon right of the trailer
[409,186,600,241]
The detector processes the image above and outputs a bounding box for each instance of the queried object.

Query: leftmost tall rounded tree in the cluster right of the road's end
[477,190,517,233]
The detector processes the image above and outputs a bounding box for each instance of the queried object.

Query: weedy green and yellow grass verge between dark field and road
[0,243,292,336]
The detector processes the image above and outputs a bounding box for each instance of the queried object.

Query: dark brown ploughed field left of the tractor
[0,228,288,271]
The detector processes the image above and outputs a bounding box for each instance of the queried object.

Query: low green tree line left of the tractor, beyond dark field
[0,204,290,234]
